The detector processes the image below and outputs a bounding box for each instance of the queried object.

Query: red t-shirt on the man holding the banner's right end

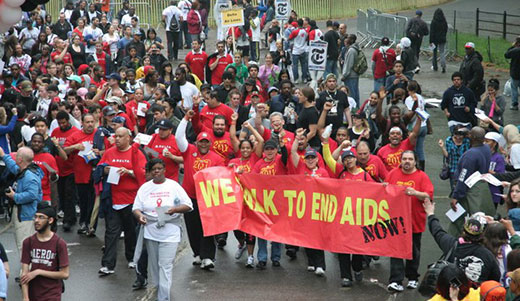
[386,168,433,233]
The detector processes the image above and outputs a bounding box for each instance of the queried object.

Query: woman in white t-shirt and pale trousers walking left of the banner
[132,158,193,301]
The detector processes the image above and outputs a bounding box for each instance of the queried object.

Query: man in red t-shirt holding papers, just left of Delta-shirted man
[64,114,96,234]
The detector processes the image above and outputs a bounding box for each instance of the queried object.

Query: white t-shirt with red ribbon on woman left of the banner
[132,179,193,242]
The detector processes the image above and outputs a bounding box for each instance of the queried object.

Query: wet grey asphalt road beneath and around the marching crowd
[0,0,519,301]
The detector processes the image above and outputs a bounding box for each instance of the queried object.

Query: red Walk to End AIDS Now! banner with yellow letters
[195,167,412,259]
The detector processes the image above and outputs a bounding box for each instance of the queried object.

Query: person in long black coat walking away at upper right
[430,8,448,73]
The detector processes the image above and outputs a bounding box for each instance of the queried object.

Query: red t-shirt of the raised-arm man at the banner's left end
[182,144,225,199]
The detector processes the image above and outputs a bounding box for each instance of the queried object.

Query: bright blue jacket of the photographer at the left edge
[3,154,43,222]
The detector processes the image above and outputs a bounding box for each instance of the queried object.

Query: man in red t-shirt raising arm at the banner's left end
[175,110,224,269]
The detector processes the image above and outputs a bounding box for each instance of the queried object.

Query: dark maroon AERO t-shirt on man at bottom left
[21,234,69,300]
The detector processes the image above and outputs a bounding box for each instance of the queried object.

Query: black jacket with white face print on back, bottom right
[428,215,500,282]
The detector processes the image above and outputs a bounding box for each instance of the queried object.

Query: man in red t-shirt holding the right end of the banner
[386,150,433,291]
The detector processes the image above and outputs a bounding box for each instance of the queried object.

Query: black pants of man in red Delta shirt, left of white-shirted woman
[101,205,136,270]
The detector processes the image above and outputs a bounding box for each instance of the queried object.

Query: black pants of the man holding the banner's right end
[390,233,422,284]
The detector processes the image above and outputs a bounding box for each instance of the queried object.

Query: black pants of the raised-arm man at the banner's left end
[184,199,216,260]
